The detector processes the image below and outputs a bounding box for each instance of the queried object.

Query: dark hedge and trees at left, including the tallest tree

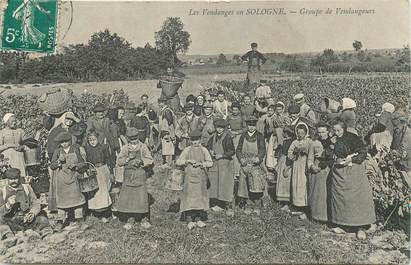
[0,17,191,83]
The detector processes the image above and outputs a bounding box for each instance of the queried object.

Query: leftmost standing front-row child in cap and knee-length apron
[50,132,86,231]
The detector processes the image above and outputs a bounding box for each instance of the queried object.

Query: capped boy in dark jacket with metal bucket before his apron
[236,117,266,215]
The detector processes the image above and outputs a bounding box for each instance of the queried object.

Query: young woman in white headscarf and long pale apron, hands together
[288,122,311,219]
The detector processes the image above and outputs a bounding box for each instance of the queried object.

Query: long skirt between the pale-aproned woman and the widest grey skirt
[308,167,330,222]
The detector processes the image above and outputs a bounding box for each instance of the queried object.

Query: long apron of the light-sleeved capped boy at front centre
[180,147,209,212]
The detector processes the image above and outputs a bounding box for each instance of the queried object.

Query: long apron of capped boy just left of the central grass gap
[117,150,149,213]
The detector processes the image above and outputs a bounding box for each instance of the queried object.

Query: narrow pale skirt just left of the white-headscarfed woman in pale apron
[275,156,291,202]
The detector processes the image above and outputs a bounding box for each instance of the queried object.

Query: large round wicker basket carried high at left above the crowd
[38,89,72,115]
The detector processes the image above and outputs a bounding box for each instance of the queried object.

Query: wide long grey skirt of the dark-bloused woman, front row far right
[330,163,376,226]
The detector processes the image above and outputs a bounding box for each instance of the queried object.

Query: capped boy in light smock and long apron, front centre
[176,130,213,229]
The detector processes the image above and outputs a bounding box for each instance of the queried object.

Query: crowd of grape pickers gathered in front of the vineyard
[0,58,411,245]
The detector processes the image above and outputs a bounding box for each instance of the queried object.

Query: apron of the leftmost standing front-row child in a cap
[55,148,86,209]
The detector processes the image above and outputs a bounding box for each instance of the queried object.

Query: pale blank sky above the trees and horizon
[59,0,410,55]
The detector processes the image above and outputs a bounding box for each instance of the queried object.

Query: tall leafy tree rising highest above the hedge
[155,17,191,65]
